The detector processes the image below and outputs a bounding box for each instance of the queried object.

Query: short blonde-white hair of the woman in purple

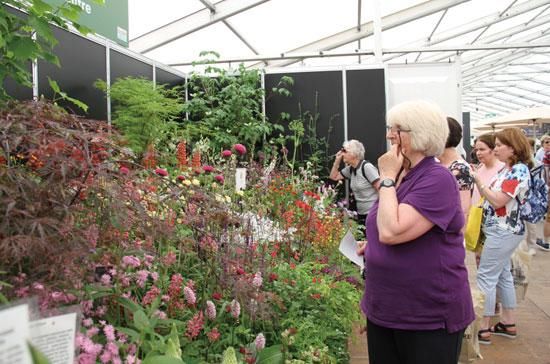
[387,100,449,156]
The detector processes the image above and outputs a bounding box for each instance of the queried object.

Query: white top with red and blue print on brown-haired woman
[483,163,531,235]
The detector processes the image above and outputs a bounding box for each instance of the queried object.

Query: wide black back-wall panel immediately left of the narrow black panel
[265,71,344,169]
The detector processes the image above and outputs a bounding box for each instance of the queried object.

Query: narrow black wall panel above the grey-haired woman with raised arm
[346,69,387,164]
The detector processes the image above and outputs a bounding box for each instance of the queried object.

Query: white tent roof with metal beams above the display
[129,0,550,126]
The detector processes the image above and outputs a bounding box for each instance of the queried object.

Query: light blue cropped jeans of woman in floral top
[477,226,523,316]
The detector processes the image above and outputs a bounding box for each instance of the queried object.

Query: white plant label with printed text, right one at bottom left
[30,313,76,364]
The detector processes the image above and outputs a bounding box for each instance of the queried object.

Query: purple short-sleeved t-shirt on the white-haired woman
[361,157,475,333]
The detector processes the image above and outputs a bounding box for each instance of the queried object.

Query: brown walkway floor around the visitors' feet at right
[350,245,550,364]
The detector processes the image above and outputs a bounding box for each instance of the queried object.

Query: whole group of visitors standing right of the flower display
[330,101,550,364]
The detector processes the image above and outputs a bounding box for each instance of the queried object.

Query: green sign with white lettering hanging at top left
[44,0,128,47]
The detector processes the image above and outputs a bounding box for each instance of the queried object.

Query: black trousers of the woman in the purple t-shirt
[367,321,464,364]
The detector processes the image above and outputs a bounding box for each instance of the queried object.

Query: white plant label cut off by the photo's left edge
[0,304,32,364]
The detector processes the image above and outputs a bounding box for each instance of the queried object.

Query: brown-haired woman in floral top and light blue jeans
[474,128,533,344]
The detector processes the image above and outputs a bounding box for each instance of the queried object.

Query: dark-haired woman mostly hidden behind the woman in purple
[438,117,474,221]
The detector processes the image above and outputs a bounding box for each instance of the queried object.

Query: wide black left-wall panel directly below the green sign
[38,27,107,120]
